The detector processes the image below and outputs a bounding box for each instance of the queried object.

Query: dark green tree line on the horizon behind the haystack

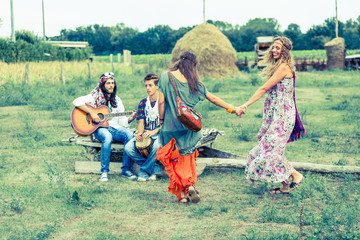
[51,16,360,54]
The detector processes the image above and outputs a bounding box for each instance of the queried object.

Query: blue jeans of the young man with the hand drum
[125,135,160,179]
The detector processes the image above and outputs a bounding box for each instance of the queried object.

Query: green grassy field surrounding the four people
[0,58,360,239]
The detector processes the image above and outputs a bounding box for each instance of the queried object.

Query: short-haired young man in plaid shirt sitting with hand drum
[125,73,160,182]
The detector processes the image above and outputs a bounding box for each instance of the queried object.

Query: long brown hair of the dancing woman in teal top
[170,51,200,93]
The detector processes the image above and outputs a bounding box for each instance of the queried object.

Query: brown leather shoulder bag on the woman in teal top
[168,72,202,132]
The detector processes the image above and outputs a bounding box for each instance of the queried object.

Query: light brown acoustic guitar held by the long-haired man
[71,105,133,137]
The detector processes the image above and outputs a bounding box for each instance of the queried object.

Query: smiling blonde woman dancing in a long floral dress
[237,37,305,194]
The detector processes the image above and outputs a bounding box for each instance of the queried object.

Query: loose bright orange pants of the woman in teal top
[156,138,199,201]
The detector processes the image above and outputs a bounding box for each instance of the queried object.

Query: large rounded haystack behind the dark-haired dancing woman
[172,23,239,79]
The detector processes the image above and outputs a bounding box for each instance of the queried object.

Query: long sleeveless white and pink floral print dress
[245,78,296,183]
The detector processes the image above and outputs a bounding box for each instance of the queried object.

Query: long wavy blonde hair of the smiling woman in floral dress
[260,37,295,78]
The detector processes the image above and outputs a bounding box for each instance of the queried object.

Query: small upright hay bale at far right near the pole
[325,38,345,70]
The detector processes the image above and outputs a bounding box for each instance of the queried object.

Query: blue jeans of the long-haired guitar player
[94,127,134,173]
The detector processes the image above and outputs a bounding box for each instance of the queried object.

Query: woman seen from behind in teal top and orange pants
[157,52,239,203]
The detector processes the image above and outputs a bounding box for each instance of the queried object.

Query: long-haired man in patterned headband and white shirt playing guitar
[73,73,136,181]
